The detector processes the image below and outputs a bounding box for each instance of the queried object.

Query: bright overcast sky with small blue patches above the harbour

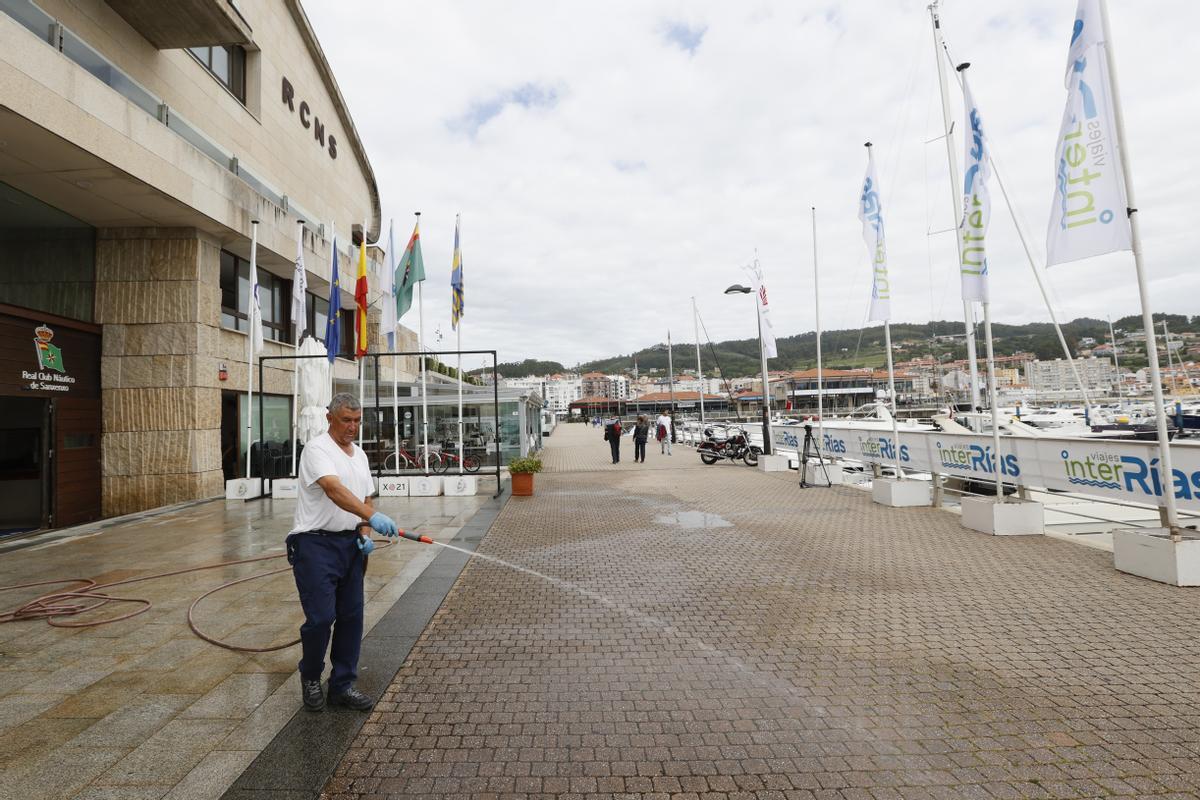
[305,0,1200,365]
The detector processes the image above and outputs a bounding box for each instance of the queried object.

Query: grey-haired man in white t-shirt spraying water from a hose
[284,392,397,711]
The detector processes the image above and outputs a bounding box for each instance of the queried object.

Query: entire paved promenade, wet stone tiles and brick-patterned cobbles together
[0,425,1200,800]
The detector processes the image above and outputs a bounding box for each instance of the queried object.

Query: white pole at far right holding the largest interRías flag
[1100,0,1181,542]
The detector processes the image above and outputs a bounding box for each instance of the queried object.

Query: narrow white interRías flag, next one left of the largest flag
[959,72,991,302]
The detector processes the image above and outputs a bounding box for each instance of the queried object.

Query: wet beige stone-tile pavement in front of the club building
[0,495,490,800]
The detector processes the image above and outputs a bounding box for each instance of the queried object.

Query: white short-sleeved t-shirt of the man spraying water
[292,432,374,534]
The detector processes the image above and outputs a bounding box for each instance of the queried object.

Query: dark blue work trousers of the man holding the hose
[288,534,365,694]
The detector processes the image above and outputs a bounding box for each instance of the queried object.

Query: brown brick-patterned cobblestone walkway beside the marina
[324,426,1200,800]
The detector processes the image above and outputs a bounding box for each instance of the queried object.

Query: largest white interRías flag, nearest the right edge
[1046,0,1132,265]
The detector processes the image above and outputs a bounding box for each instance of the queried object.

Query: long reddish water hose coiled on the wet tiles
[0,530,434,652]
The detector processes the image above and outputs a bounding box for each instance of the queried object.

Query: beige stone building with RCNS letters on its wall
[0,0,416,530]
